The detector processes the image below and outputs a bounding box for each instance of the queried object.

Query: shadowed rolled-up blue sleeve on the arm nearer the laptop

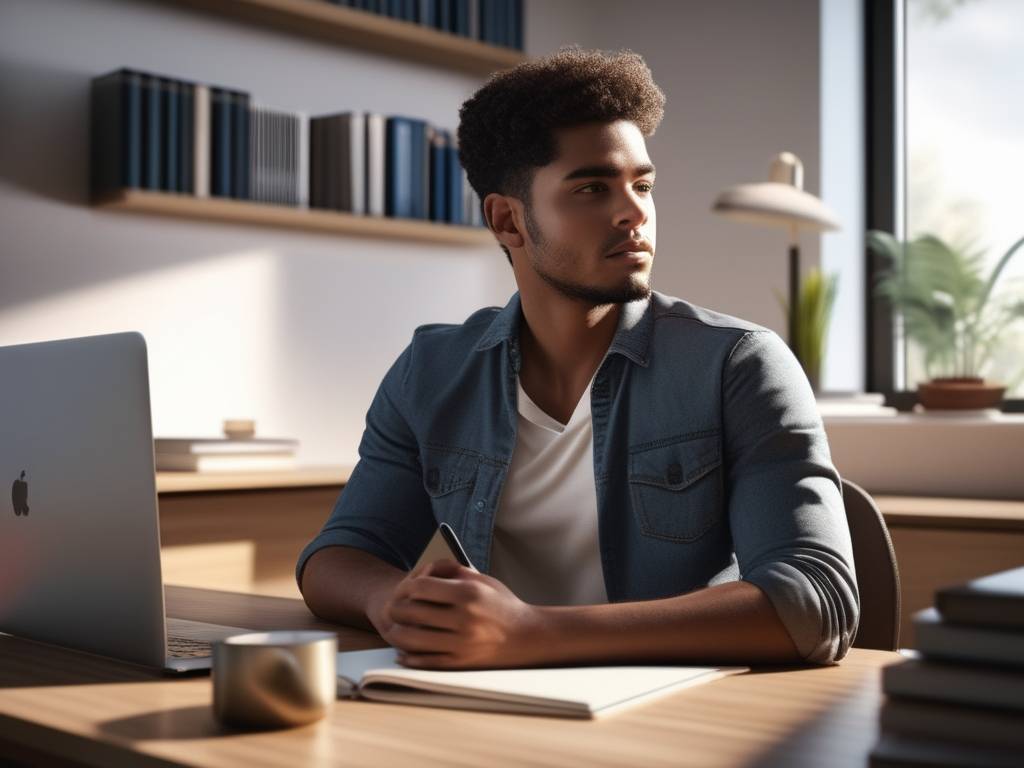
[295,348,436,585]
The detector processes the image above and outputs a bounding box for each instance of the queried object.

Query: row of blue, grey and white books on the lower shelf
[90,69,483,226]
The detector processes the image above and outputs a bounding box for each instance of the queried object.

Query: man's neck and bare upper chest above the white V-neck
[519,293,622,424]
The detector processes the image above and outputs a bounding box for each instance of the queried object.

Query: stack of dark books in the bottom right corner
[871,567,1024,766]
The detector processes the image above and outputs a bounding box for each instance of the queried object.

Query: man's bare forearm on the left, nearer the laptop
[301,547,406,631]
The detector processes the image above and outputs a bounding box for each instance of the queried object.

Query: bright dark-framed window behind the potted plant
[865,0,1024,411]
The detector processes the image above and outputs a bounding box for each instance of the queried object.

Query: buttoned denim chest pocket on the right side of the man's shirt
[629,433,723,542]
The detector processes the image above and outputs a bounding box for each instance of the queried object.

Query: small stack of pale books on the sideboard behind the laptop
[154,437,298,472]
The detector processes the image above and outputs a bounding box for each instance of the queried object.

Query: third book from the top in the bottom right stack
[882,654,1024,713]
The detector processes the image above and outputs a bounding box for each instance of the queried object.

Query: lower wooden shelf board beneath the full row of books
[95,189,494,246]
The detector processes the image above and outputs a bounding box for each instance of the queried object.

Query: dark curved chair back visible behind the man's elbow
[843,480,900,650]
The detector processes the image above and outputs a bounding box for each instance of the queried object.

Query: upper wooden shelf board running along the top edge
[166,0,525,75]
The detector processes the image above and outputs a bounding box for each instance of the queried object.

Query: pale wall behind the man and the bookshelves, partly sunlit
[0,0,818,462]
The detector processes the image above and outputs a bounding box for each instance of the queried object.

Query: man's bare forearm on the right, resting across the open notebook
[537,582,802,665]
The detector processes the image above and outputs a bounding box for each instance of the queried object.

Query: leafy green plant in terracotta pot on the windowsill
[867,229,1024,409]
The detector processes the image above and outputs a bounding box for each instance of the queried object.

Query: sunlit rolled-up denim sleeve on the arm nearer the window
[723,330,860,664]
